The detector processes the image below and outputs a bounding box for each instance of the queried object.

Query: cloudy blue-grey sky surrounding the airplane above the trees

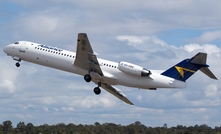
[0,0,221,127]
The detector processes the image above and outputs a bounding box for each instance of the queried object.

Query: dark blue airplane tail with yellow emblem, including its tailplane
[162,52,217,82]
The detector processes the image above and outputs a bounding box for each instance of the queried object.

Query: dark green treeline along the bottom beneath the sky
[0,121,221,134]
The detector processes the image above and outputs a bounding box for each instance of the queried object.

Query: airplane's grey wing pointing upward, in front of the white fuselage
[74,33,103,76]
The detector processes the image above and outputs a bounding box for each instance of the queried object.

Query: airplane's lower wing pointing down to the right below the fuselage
[101,83,134,105]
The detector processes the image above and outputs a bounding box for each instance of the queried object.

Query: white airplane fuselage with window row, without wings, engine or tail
[4,41,186,89]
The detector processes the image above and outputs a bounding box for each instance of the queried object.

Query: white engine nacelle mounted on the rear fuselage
[118,61,151,76]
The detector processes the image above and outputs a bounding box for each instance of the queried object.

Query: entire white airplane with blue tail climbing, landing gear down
[3,33,217,105]
